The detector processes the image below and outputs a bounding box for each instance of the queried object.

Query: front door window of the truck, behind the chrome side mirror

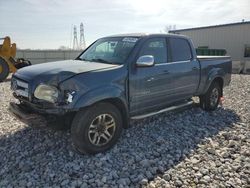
[139,38,167,64]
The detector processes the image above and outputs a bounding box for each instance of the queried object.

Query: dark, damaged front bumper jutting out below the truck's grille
[9,102,47,126]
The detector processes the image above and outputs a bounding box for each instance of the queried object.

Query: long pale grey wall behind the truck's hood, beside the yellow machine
[16,50,82,64]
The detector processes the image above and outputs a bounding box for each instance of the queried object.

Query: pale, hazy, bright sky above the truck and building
[0,0,250,49]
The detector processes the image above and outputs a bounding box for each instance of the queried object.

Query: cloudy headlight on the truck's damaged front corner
[34,84,58,103]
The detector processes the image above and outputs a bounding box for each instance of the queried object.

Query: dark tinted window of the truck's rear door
[169,38,192,62]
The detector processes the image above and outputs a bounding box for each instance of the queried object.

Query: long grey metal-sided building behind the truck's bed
[170,21,250,73]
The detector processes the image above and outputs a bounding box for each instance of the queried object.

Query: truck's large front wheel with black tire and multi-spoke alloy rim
[71,103,123,154]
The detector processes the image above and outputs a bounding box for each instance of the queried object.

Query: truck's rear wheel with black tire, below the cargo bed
[200,82,222,111]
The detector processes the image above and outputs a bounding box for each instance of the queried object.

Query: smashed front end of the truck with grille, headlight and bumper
[9,75,80,126]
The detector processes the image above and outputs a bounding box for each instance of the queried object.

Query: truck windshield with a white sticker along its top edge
[78,37,138,64]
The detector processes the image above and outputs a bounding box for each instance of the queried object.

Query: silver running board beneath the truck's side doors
[131,101,194,120]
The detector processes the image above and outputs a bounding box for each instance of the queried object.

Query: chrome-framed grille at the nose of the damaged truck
[11,77,29,98]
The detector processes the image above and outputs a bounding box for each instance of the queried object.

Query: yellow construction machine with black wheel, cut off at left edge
[0,36,31,82]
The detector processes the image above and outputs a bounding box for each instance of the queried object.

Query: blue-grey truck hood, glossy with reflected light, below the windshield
[14,60,119,83]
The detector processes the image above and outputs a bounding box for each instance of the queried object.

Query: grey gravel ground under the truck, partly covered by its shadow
[0,75,250,188]
